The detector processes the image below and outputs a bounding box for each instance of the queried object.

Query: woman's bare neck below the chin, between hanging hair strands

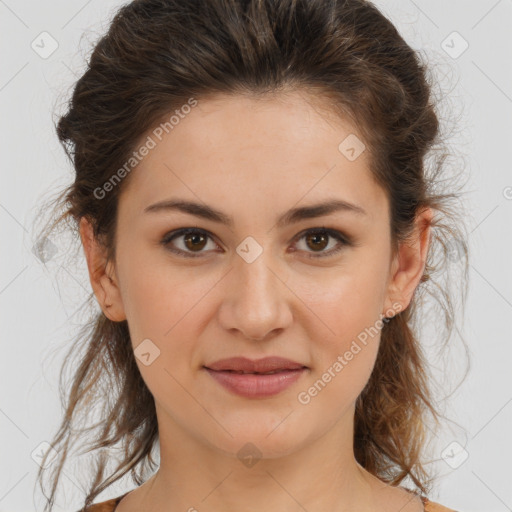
[134,404,382,512]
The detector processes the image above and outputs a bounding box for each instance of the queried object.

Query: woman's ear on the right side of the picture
[383,208,433,314]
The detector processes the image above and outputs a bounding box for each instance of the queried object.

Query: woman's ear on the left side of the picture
[80,217,126,322]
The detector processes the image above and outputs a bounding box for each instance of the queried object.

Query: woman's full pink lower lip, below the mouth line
[205,367,307,398]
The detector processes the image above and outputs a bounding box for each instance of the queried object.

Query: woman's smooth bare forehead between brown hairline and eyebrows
[121,93,385,223]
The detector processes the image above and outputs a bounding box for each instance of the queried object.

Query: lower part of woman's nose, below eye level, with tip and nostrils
[219,251,294,341]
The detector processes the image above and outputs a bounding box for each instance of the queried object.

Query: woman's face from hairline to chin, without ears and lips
[103,93,407,457]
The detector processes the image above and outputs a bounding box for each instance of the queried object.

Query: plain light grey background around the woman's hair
[0,0,512,512]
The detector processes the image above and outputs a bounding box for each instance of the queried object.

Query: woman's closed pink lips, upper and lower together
[204,357,309,398]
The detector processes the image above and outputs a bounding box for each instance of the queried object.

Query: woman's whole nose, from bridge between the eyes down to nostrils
[221,237,291,339]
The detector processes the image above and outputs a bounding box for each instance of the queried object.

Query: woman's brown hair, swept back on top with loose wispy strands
[33,0,468,511]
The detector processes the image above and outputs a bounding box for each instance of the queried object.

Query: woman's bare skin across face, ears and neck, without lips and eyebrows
[80,92,432,512]
